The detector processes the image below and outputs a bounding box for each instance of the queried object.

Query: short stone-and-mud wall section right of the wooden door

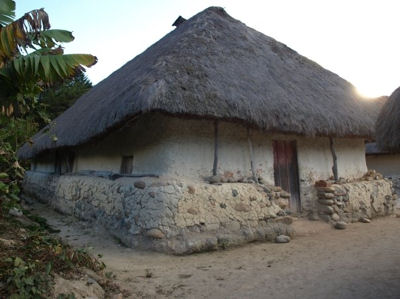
[316,176,396,222]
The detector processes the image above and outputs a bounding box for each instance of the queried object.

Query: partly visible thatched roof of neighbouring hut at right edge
[376,87,400,152]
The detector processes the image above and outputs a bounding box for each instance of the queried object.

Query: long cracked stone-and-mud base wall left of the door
[23,172,292,254]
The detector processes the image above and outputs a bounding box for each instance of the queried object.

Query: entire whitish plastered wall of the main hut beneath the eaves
[71,114,367,183]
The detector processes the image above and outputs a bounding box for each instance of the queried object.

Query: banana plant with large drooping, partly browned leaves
[0,0,97,115]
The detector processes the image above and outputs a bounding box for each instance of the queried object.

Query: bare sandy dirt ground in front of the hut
[33,204,400,298]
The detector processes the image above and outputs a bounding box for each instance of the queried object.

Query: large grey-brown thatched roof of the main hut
[19,7,384,158]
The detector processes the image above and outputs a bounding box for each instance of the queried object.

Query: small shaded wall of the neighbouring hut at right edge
[366,154,400,176]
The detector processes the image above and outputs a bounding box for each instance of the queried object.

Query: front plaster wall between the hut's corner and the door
[160,118,273,183]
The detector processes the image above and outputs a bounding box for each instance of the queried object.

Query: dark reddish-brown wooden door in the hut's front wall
[273,140,301,212]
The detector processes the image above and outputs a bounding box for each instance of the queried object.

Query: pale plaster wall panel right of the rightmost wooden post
[335,138,367,178]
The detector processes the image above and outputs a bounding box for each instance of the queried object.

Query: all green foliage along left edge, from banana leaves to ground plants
[0,0,104,298]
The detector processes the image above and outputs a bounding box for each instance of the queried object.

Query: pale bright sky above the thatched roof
[16,0,400,97]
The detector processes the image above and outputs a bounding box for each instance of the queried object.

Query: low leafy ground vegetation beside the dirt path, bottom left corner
[0,214,105,298]
